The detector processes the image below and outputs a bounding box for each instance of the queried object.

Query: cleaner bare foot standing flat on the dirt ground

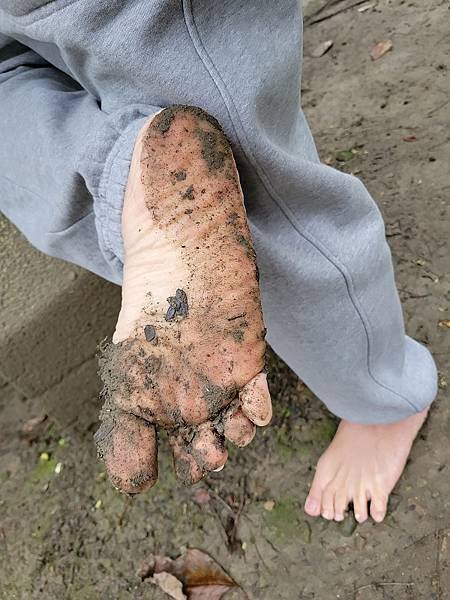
[305,410,428,523]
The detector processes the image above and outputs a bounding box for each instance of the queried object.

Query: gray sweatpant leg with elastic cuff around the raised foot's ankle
[0,36,157,283]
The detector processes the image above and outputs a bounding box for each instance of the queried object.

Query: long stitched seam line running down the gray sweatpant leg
[182,0,419,412]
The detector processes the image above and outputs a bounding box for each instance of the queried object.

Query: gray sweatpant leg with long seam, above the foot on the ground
[0,0,436,423]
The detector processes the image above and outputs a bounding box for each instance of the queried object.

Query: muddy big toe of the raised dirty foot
[94,411,158,494]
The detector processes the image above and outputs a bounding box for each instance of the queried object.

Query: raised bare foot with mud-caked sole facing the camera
[96,106,271,493]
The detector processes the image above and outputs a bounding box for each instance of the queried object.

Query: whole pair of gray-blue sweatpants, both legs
[0,0,436,423]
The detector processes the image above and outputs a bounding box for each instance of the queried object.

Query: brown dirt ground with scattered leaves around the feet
[0,0,450,600]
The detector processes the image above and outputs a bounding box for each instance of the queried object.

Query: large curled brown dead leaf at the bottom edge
[144,549,236,600]
